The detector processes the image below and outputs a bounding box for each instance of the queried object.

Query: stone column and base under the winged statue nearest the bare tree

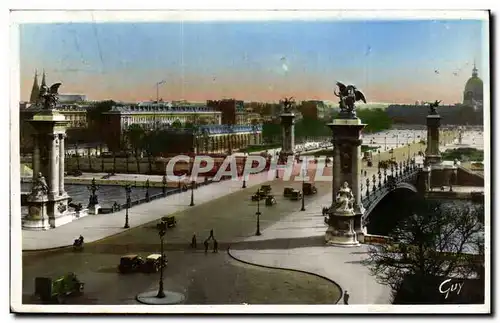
[325,118,366,246]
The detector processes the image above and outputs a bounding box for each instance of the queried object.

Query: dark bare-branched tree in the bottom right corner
[364,198,484,304]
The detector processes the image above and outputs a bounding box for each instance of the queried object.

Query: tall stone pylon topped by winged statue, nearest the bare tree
[325,83,366,247]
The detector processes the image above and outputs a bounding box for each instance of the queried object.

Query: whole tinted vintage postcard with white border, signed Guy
[10,11,491,314]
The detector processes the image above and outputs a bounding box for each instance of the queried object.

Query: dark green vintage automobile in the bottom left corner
[35,273,84,304]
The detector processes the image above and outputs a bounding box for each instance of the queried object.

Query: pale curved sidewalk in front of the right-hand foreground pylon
[229,194,390,304]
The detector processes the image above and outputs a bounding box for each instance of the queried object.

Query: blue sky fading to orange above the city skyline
[20,19,488,104]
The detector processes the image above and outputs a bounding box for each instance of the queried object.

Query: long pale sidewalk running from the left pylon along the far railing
[22,172,274,251]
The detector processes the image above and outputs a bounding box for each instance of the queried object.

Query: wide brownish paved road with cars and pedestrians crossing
[23,168,339,304]
